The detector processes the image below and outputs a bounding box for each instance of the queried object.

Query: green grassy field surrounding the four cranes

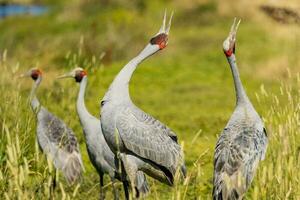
[0,0,300,199]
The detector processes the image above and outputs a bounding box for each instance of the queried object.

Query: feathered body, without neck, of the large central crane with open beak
[101,104,185,185]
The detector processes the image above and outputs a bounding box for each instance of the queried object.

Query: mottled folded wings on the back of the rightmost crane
[214,127,267,187]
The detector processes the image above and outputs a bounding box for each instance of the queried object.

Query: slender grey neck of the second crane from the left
[76,76,92,126]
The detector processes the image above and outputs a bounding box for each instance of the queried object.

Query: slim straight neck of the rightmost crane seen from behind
[227,54,250,105]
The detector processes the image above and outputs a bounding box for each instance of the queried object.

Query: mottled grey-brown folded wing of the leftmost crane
[37,107,84,183]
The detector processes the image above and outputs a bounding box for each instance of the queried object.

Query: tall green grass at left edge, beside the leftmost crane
[0,51,79,199]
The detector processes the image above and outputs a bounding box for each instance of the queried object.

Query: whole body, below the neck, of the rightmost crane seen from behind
[214,100,267,199]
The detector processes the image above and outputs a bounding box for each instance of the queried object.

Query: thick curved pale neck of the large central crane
[103,44,159,103]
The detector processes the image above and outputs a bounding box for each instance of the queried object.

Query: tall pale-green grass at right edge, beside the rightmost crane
[251,72,300,199]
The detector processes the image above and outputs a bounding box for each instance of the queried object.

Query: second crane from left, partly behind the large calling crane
[59,67,149,199]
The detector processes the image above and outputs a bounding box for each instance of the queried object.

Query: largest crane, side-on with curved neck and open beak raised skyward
[100,13,186,195]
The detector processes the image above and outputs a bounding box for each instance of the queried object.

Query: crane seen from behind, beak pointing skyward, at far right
[213,19,268,200]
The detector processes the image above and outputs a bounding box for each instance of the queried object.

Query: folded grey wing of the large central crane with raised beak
[116,108,182,173]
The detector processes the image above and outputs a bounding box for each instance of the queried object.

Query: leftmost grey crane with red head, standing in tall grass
[20,68,84,188]
